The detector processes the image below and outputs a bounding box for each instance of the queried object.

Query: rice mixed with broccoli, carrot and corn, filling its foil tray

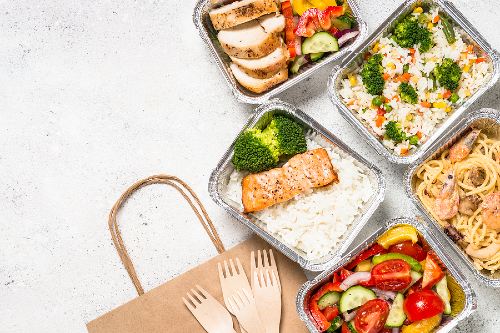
[339,7,492,156]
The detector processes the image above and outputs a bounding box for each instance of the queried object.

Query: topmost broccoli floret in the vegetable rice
[393,16,432,52]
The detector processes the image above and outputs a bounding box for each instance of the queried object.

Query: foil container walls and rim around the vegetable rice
[328,0,500,164]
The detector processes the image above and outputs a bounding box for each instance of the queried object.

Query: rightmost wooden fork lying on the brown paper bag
[253,268,281,333]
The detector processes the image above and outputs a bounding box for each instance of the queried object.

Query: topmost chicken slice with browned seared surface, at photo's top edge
[209,0,278,30]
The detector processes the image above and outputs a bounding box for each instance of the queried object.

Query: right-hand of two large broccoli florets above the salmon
[264,115,307,155]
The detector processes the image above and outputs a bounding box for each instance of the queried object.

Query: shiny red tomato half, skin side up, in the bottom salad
[403,289,444,321]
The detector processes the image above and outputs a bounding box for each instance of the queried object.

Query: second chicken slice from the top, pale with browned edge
[217,20,281,59]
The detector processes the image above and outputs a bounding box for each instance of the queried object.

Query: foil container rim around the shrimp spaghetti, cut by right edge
[405,108,500,288]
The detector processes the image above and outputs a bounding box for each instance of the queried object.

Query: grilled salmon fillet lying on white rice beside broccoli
[241,148,339,213]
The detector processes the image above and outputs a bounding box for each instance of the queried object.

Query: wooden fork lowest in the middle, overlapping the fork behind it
[228,288,266,333]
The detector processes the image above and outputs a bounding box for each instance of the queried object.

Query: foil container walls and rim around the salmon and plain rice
[208,99,386,271]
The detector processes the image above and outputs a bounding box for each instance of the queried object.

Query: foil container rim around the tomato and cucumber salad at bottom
[296,217,477,333]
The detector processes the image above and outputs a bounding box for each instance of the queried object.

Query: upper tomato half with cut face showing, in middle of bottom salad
[372,259,411,291]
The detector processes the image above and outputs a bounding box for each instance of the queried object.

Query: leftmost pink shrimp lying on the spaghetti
[434,169,460,220]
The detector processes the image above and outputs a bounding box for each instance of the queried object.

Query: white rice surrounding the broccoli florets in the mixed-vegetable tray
[339,8,492,155]
